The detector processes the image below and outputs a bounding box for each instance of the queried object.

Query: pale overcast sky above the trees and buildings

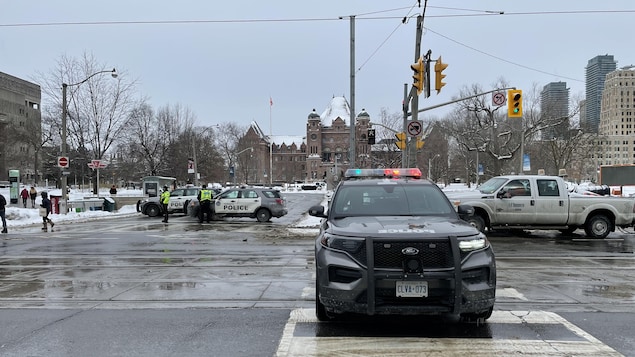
[0,0,635,135]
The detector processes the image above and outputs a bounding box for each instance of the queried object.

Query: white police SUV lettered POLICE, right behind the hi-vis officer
[188,187,287,222]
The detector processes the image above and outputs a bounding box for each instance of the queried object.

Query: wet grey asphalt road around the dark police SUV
[0,194,635,356]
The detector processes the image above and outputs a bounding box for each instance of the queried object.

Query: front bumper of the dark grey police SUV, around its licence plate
[316,238,496,315]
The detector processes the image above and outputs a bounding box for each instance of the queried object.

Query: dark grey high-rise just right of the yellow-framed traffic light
[540,82,569,140]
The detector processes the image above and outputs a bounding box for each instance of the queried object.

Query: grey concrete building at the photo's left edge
[0,72,42,183]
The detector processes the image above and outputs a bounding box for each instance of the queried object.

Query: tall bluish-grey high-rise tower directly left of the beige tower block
[580,54,617,133]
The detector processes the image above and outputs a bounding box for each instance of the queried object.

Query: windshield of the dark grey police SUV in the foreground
[330,180,456,218]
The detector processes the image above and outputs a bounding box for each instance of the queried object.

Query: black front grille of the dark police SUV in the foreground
[350,239,454,269]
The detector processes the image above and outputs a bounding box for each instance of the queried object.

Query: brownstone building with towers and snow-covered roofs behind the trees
[235,97,371,184]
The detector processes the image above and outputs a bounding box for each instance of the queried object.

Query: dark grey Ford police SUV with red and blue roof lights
[309,169,496,322]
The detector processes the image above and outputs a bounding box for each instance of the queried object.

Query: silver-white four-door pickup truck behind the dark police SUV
[446,175,635,239]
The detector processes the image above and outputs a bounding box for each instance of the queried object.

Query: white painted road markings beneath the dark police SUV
[276,309,623,357]
